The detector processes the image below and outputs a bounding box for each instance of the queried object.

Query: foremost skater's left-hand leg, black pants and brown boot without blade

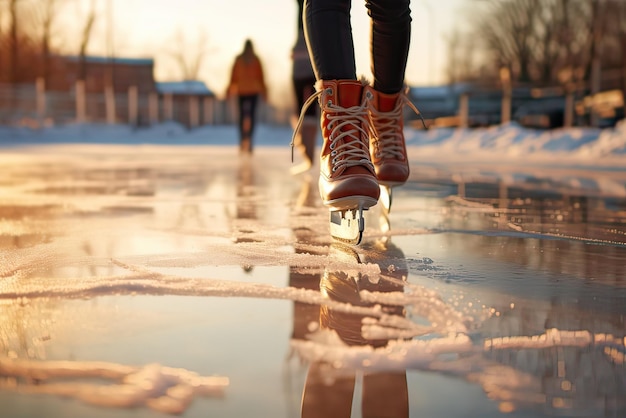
[304,0,380,211]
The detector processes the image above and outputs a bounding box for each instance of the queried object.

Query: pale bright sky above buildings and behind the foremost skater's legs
[59,0,466,105]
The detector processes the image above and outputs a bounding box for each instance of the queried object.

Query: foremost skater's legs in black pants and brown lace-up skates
[290,0,419,243]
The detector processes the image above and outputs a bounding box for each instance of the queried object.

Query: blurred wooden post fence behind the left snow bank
[0,81,290,129]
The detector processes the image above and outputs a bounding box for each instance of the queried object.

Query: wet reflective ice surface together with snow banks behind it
[0,121,626,418]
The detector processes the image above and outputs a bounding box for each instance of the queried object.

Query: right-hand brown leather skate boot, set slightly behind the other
[364,86,409,187]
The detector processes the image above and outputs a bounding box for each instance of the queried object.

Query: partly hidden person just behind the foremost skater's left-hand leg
[291,0,319,174]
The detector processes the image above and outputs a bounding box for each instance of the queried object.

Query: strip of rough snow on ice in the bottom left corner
[0,358,228,414]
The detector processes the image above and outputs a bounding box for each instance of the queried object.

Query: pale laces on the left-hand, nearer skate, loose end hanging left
[291,90,374,172]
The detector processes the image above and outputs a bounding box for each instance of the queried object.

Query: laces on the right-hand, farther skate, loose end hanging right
[366,88,428,160]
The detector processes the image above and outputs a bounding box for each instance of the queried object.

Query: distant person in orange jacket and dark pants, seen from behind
[227,39,267,154]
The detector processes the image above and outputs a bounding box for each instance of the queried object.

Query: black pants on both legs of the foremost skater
[303,0,411,94]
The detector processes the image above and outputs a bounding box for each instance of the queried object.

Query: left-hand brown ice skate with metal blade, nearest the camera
[292,80,380,244]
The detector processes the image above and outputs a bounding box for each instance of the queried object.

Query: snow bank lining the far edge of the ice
[0,119,626,163]
